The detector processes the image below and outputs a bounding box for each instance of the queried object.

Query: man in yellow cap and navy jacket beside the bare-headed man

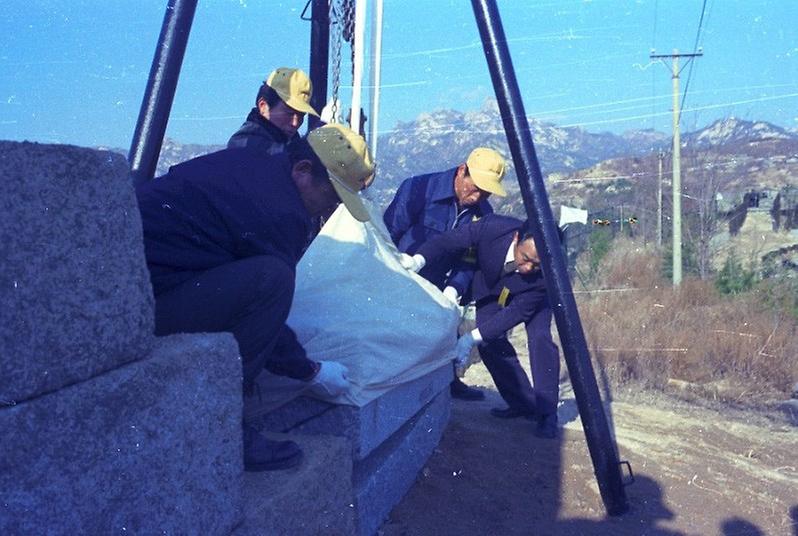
[383,147,507,400]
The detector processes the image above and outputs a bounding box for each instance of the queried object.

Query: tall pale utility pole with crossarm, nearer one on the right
[649,49,704,287]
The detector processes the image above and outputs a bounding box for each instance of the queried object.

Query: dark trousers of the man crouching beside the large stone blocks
[155,255,294,387]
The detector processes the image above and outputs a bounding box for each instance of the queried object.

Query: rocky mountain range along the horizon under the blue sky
[157,107,798,220]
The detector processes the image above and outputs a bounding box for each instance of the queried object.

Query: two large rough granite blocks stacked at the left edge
[0,142,243,535]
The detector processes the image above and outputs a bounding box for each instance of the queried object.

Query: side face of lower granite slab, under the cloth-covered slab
[352,389,451,536]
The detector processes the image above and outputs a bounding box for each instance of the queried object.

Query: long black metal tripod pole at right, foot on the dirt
[471,0,629,515]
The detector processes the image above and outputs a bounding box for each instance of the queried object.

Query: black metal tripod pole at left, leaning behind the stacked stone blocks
[128,0,197,184]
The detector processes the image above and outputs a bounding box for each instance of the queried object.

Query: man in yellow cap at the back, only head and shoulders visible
[227,67,319,154]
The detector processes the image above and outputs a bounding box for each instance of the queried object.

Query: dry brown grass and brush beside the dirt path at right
[575,238,798,405]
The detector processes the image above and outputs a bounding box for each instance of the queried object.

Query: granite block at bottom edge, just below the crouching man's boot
[233,434,355,536]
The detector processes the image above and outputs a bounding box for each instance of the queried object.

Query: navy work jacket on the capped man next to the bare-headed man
[383,168,493,296]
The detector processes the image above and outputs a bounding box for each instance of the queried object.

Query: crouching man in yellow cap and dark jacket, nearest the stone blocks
[136,125,374,471]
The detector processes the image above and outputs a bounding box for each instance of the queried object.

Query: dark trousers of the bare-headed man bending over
[477,307,560,415]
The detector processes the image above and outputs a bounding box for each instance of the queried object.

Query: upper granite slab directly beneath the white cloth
[252,363,453,460]
